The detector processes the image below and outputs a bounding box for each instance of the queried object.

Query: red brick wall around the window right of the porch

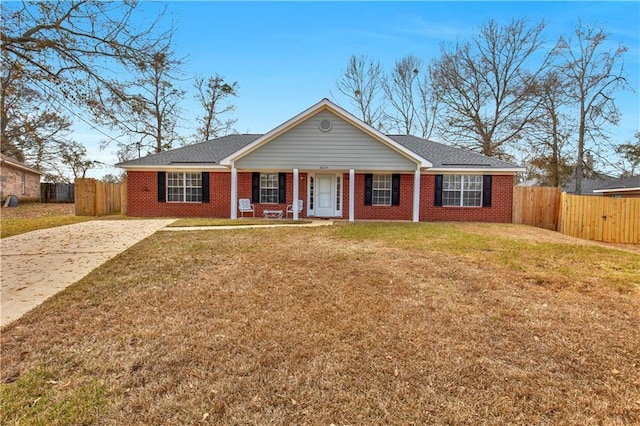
[420,175,514,223]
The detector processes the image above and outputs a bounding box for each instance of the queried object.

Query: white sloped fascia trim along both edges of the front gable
[220,98,433,167]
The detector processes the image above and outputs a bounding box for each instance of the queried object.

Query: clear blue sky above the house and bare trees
[82,1,640,177]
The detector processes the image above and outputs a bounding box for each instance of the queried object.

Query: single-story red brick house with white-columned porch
[117,99,523,222]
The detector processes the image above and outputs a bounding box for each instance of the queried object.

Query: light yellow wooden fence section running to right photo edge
[558,193,640,244]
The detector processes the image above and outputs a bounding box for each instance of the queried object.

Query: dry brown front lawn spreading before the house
[0,223,640,425]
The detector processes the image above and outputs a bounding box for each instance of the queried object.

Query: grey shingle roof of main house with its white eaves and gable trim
[117,99,524,173]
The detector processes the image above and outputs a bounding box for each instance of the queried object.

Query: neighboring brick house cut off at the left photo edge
[0,154,42,201]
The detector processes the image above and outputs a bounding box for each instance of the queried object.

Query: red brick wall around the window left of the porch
[127,172,231,218]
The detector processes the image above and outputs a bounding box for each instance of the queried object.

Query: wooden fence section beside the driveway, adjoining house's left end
[75,179,127,216]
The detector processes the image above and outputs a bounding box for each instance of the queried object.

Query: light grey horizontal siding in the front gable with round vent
[235,111,416,171]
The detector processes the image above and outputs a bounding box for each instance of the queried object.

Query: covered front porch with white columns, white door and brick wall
[230,168,421,222]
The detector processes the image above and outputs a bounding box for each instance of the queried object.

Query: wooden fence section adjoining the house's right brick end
[512,186,560,231]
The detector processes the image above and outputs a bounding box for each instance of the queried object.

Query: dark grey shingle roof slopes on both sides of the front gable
[117,134,517,169]
